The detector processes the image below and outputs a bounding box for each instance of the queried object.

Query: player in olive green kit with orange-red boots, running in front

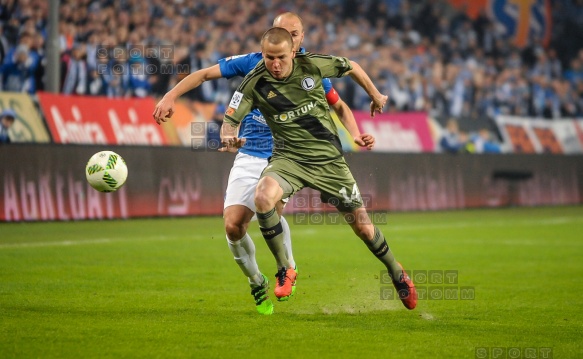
[221,27,417,309]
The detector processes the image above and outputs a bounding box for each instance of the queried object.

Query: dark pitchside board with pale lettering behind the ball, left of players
[0,144,227,222]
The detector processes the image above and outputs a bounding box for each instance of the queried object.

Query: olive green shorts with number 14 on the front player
[261,157,362,212]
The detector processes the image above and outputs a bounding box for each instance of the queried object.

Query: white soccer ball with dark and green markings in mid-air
[85,151,128,192]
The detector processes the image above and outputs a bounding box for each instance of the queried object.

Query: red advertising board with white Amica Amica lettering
[38,93,170,146]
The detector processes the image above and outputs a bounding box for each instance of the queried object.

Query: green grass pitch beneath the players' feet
[0,206,583,358]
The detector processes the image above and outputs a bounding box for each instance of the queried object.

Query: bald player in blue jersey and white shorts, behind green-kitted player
[153,12,376,314]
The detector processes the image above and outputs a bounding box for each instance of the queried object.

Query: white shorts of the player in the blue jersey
[223,152,267,212]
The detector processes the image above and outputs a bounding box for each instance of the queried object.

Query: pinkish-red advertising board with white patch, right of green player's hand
[354,111,435,152]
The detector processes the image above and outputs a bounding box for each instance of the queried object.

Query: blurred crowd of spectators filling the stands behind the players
[0,0,583,124]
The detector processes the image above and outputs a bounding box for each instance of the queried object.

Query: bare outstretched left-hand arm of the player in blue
[153,64,223,124]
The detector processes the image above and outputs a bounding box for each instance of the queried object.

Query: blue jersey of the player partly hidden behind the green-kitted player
[219,48,332,158]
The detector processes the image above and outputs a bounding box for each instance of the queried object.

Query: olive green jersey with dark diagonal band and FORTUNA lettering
[225,53,352,164]
